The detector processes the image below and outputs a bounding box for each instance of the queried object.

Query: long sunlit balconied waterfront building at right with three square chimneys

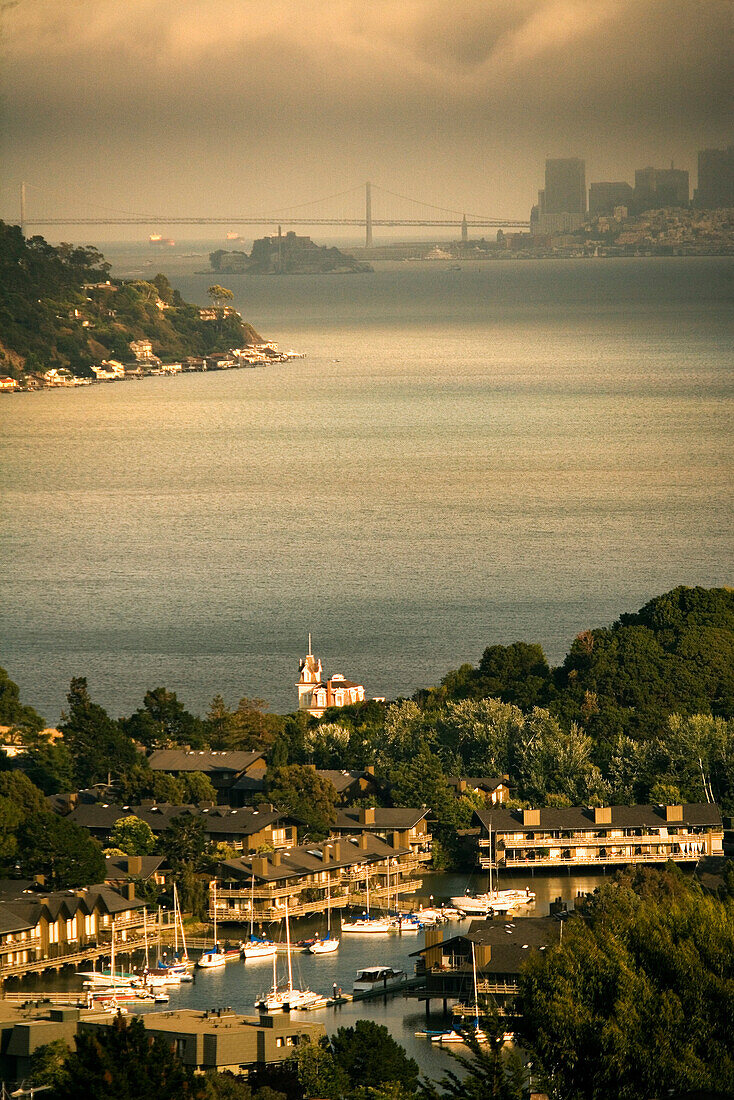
[473,802,724,871]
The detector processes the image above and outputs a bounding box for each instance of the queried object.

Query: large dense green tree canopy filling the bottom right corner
[522,868,734,1100]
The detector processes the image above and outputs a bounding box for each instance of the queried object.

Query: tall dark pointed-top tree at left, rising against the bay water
[59,677,138,787]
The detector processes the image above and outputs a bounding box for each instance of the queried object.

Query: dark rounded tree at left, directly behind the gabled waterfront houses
[18,813,105,888]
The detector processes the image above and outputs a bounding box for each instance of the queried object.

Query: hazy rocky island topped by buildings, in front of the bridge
[209,231,372,275]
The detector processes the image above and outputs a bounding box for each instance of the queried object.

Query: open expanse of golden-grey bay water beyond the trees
[0,255,734,722]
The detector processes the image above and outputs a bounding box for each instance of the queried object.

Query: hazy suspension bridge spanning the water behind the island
[20,183,529,248]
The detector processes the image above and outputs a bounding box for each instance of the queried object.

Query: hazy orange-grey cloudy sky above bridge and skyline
[0,0,734,237]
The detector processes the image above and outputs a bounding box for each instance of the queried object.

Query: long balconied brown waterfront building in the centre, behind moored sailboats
[209,833,420,924]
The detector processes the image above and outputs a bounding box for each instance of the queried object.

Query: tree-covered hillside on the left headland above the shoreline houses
[0,222,262,378]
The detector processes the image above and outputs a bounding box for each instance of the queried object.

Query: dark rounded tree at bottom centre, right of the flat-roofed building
[331,1020,418,1092]
